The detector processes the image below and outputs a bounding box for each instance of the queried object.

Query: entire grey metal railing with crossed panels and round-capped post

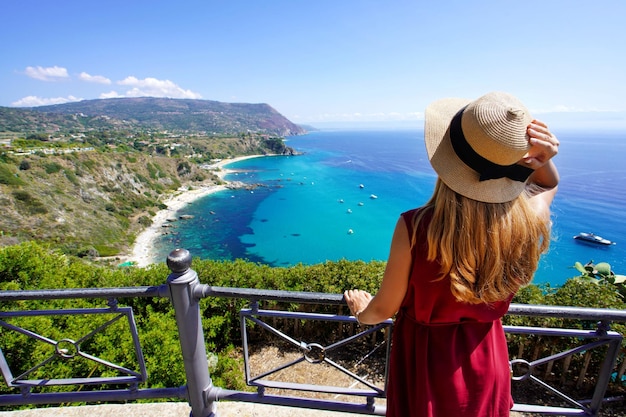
[0,249,626,417]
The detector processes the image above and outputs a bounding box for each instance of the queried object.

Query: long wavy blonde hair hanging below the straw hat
[412,179,550,304]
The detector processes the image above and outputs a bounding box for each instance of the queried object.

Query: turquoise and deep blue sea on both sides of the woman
[155,130,626,285]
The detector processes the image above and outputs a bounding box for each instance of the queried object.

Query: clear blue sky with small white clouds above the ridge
[0,0,626,127]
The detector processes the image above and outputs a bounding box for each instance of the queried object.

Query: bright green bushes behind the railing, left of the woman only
[0,242,384,393]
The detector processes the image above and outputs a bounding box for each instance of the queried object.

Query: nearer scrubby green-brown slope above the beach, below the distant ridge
[0,134,294,256]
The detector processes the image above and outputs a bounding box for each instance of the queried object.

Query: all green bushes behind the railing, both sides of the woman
[0,242,626,404]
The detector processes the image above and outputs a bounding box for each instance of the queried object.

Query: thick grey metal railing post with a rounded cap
[167,249,215,417]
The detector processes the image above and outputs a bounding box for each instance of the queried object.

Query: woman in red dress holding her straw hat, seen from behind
[344,92,559,417]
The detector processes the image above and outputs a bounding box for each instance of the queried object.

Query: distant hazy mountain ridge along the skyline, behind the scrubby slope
[0,97,305,136]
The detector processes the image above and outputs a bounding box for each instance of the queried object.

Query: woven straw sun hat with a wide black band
[424,92,532,203]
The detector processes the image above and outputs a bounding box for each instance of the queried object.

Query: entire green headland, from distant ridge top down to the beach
[0,98,305,256]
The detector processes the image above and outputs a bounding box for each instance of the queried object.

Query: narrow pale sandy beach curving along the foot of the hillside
[125,155,268,268]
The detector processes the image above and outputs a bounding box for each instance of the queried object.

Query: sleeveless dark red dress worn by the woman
[387,210,513,417]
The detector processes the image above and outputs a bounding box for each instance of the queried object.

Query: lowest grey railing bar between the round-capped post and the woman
[210,389,387,416]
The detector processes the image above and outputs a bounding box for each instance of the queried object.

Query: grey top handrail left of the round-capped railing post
[0,285,169,301]
